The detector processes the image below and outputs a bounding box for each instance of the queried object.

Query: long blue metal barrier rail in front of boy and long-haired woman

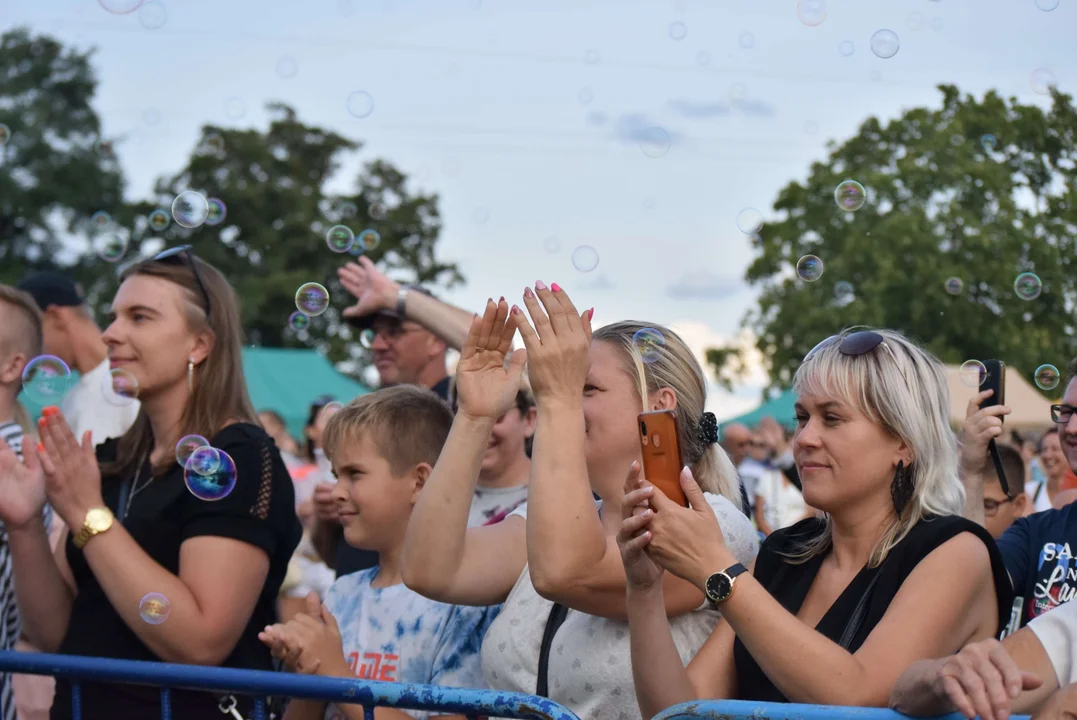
[0,651,579,720]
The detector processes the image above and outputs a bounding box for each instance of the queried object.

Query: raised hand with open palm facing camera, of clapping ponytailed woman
[457,298,528,420]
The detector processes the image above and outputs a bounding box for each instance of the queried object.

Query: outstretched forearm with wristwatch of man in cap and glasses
[337,256,473,350]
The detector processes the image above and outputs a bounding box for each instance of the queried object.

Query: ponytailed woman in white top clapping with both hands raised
[403,283,757,720]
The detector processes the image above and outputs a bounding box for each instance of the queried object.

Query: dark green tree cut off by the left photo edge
[0,28,123,284]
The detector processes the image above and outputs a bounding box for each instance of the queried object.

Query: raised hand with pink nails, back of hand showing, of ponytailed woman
[513,281,595,406]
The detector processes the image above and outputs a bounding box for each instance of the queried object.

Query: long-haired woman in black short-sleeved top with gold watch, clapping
[0,249,300,720]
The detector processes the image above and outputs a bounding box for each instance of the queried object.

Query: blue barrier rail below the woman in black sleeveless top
[654,700,1029,720]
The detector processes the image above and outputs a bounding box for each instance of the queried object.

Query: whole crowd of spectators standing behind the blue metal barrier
[0,248,1077,720]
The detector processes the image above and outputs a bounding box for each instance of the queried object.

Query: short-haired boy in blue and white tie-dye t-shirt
[260,385,500,720]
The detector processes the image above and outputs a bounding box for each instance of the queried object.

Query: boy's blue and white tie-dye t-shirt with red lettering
[325,567,501,720]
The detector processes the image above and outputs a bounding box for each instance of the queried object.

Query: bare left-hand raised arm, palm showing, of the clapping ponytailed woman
[402,300,527,605]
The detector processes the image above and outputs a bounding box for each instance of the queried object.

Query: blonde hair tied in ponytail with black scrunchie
[591,320,741,507]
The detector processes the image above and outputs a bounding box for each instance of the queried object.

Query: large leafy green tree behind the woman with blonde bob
[711,86,1077,398]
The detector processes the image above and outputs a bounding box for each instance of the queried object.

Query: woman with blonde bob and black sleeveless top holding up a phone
[618,330,1010,717]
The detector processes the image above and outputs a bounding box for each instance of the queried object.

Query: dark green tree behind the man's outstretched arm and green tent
[89,103,463,362]
